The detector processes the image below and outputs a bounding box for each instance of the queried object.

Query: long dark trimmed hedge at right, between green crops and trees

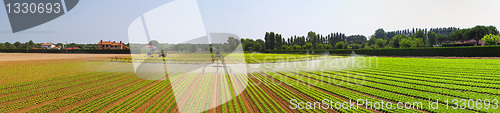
[265,46,500,57]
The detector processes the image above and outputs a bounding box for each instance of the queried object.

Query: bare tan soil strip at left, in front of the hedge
[0,53,130,64]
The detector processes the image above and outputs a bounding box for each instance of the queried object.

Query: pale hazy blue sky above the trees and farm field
[0,0,500,43]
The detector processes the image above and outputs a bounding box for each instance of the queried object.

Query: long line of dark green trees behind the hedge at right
[237,26,498,51]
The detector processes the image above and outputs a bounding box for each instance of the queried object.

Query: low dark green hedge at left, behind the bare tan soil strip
[0,49,130,54]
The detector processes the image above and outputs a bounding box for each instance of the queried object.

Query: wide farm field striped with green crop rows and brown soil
[0,54,500,113]
